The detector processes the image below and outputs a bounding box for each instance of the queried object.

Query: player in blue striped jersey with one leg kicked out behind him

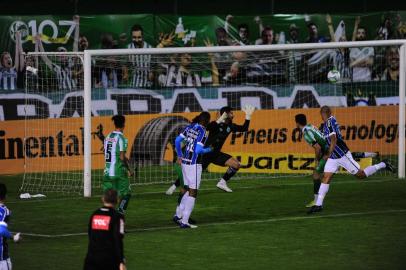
[308,106,394,214]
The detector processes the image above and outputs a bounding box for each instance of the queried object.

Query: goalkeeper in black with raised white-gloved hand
[206,105,255,192]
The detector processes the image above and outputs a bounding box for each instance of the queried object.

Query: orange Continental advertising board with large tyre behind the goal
[0,106,398,174]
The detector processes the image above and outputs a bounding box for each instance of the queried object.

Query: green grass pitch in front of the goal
[0,175,406,270]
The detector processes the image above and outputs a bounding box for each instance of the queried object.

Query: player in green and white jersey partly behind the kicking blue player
[295,114,378,208]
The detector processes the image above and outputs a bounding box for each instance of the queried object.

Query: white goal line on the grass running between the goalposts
[7,179,396,204]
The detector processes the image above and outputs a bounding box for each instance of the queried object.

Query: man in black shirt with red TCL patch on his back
[84,189,126,270]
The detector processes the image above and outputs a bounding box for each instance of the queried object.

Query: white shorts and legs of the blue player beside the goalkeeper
[180,164,202,228]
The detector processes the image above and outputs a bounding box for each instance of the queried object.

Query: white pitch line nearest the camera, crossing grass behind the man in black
[17,209,406,238]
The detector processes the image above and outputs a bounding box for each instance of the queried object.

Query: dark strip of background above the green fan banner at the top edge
[0,0,406,15]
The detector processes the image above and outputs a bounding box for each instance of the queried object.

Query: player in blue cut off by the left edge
[0,183,21,270]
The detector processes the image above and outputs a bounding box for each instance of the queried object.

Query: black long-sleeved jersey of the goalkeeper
[205,120,250,152]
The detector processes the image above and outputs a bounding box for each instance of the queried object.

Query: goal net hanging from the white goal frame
[22,41,404,193]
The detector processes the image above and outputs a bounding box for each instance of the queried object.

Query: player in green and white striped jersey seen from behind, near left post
[103,115,133,214]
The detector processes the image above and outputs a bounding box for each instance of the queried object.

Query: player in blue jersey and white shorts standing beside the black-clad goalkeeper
[175,112,212,228]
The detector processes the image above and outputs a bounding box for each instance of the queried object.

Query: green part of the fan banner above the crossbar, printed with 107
[0,11,406,52]
